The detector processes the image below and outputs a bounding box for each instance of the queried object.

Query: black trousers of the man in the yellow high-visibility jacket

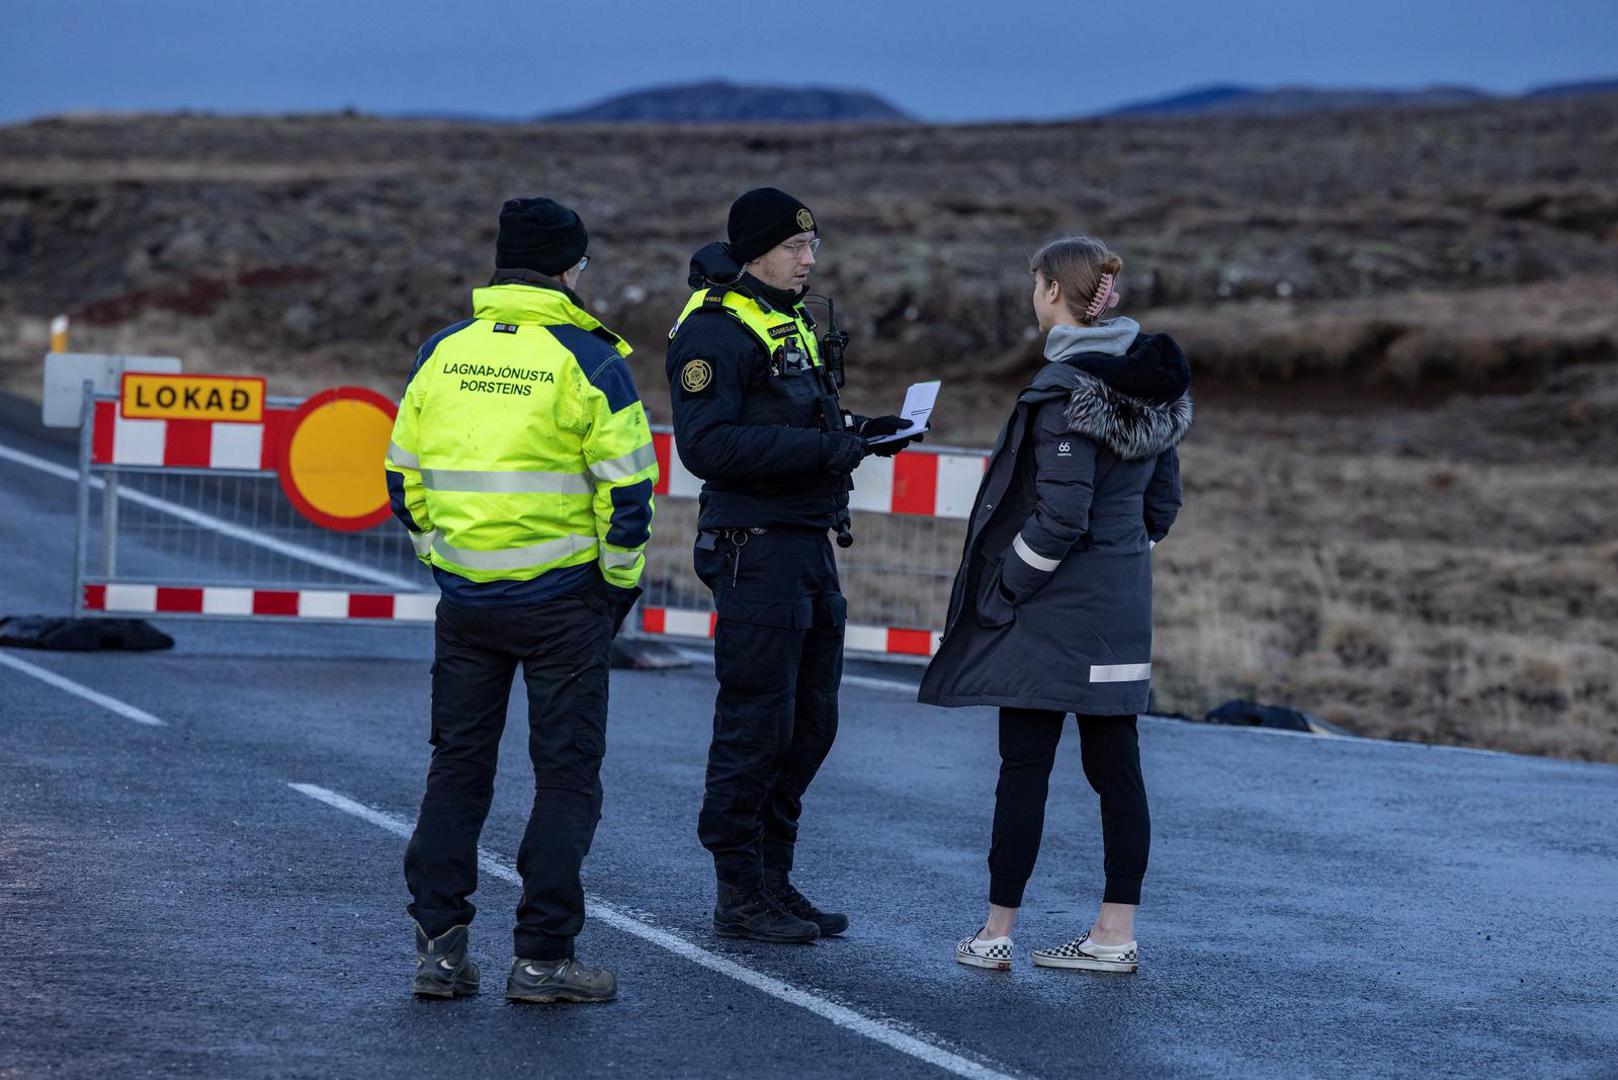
[405,585,613,960]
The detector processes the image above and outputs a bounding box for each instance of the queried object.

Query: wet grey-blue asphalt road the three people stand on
[0,429,1618,1078]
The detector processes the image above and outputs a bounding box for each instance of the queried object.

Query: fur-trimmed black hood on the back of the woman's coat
[1029,334,1194,461]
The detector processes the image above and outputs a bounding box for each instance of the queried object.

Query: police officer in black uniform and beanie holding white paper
[667,188,903,942]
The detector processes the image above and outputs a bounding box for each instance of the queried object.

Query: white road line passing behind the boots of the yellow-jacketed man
[288,784,1010,1080]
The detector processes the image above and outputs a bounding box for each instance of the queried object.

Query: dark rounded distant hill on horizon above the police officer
[540,81,911,123]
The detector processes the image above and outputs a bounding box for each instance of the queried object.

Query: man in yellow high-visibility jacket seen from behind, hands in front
[387,199,657,1002]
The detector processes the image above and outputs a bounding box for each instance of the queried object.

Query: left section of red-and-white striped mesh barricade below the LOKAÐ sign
[73,386,438,625]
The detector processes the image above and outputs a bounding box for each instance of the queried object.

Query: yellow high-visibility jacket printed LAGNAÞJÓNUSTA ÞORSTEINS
[385,272,657,602]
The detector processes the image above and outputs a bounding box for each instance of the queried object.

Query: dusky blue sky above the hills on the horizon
[0,0,1618,121]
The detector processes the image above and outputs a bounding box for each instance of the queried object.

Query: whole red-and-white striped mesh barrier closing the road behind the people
[73,382,985,656]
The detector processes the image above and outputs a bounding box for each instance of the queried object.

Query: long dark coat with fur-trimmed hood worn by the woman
[919,334,1192,716]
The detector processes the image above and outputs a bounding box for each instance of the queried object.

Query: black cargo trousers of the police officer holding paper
[693,526,848,891]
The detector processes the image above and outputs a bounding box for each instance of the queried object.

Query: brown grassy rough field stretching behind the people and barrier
[0,97,1618,761]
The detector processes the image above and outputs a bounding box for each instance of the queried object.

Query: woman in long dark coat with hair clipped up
[919,236,1192,972]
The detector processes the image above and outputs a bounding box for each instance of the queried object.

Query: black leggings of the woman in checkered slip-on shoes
[989,709,1152,907]
